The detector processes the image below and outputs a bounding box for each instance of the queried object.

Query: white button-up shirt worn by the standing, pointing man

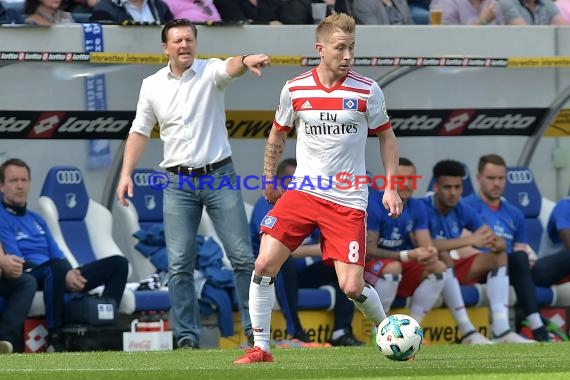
[129,58,235,168]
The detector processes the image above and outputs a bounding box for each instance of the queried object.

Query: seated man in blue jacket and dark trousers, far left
[0,159,129,351]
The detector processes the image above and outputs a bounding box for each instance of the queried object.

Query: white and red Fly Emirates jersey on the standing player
[274,69,391,210]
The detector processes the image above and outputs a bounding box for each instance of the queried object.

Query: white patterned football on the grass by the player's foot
[376,314,424,361]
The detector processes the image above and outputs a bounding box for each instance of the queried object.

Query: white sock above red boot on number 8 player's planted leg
[249,272,275,352]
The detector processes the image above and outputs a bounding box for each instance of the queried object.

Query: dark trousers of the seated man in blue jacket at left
[31,256,129,333]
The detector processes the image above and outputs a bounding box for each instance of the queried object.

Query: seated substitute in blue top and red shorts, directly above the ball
[364,157,447,324]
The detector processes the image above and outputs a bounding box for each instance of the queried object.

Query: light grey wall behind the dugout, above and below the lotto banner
[0,25,570,209]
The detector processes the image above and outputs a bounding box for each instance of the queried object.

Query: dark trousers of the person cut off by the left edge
[0,273,37,352]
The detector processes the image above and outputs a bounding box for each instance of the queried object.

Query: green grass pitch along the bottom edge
[0,343,570,380]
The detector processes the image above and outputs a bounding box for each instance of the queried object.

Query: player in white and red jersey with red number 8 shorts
[234,14,402,364]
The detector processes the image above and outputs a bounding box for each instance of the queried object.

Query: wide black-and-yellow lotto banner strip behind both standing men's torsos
[0,108,570,140]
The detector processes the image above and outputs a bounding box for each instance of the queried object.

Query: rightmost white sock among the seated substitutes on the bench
[487,267,511,336]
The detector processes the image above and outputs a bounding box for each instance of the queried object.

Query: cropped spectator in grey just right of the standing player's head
[352,0,414,25]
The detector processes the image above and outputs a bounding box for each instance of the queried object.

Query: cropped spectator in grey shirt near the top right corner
[498,0,568,25]
